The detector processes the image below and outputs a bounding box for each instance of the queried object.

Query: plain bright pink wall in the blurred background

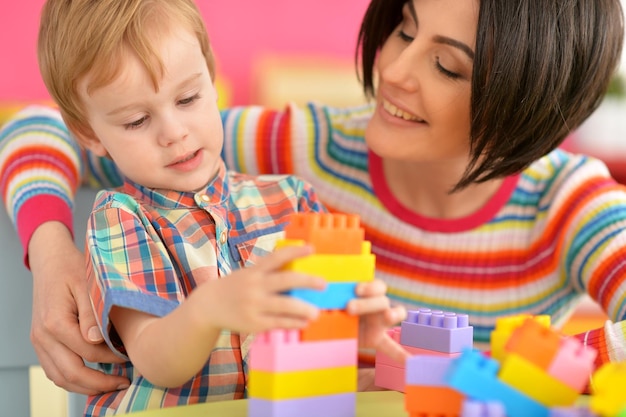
[0,0,369,104]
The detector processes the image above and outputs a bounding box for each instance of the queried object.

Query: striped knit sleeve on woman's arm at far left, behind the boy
[0,106,121,266]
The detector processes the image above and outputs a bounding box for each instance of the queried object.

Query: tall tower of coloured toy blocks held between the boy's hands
[248,213,375,417]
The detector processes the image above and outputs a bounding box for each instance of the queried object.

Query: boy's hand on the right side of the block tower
[348,280,410,363]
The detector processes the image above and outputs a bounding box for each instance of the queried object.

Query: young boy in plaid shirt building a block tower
[39,0,403,416]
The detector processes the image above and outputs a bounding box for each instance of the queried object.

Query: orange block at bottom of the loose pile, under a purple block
[404,385,465,416]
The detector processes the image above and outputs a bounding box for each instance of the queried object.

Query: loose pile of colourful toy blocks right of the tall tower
[390,310,604,417]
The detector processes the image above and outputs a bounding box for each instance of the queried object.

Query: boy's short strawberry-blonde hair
[38,0,215,133]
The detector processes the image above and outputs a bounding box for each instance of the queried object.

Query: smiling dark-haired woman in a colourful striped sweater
[0,0,626,393]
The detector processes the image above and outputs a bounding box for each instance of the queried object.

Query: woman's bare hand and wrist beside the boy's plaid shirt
[28,222,129,395]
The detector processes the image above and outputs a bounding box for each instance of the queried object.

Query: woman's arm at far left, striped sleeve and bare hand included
[0,106,128,394]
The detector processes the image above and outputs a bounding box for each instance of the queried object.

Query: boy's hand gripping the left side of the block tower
[200,246,326,332]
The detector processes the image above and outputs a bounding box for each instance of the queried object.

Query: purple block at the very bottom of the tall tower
[248,392,356,417]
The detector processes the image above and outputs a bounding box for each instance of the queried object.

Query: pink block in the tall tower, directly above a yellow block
[250,330,358,372]
